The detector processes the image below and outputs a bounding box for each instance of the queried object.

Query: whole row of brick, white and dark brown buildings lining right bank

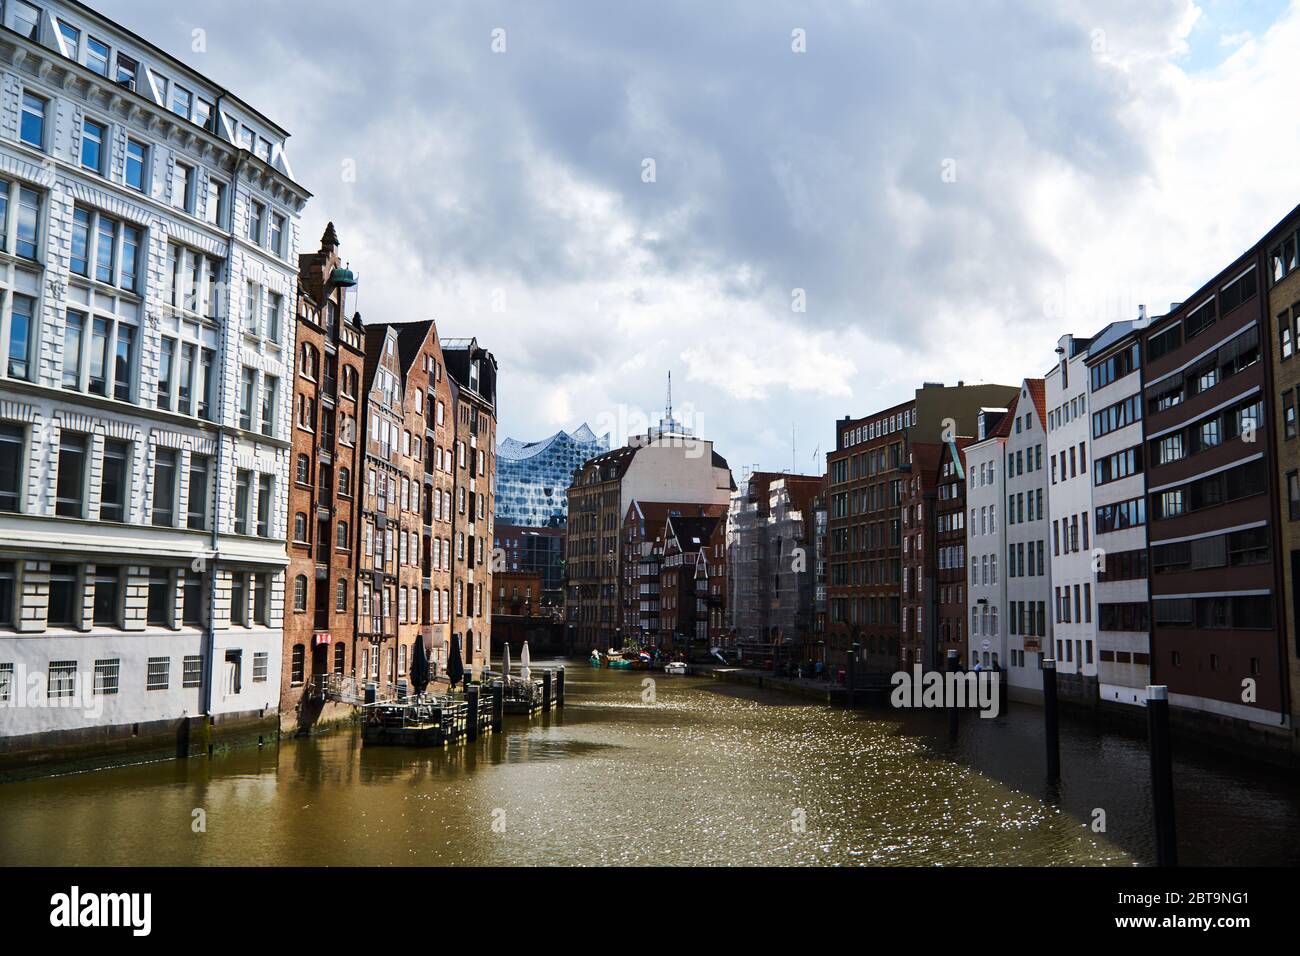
[826,209,1300,747]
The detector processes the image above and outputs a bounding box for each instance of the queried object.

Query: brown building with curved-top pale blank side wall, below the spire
[566,419,736,648]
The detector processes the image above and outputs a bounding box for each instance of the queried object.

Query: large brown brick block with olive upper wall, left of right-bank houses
[827,382,1017,670]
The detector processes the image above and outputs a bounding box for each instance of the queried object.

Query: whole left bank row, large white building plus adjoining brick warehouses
[0,0,495,760]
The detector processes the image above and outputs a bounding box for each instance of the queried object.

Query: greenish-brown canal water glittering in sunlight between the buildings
[0,663,1300,866]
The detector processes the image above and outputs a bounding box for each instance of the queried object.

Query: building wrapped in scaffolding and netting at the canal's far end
[727,471,822,644]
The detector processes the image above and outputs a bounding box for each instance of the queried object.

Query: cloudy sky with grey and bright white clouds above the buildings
[109,0,1300,479]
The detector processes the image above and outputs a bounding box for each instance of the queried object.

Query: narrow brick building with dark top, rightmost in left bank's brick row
[442,338,497,674]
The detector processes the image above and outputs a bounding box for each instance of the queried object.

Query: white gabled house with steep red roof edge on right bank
[1005,378,1052,697]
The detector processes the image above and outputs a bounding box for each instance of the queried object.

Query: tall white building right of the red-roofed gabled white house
[1045,336,1097,700]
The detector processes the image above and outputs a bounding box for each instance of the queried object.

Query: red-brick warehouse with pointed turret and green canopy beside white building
[280,222,364,730]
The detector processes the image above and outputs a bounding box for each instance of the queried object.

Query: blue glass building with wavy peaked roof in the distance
[495,424,610,528]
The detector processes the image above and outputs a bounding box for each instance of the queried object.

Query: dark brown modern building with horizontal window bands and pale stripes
[1144,240,1296,737]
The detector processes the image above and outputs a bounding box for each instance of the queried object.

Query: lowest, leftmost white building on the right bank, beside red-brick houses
[966,408,1015,669]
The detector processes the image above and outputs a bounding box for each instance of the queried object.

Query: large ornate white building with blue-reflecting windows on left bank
[0,0,308,760]
